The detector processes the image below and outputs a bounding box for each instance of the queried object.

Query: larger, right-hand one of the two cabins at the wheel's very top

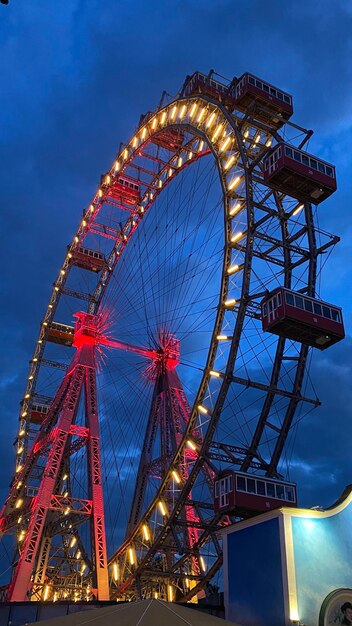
[232,72,293,129]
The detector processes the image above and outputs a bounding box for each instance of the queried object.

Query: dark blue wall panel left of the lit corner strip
[226,518,285,626]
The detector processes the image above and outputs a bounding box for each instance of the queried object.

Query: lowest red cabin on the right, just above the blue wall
[214,470,297,513]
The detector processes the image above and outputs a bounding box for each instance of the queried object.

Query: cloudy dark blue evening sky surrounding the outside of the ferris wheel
[0,0,352,564]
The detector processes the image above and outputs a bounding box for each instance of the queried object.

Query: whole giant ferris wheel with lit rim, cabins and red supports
[0,67,344,601]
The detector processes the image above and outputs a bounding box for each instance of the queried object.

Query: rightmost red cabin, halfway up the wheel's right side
[261,287,345,350]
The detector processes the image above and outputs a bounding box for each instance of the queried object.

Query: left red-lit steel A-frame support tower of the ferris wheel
[0,314,109,602]
